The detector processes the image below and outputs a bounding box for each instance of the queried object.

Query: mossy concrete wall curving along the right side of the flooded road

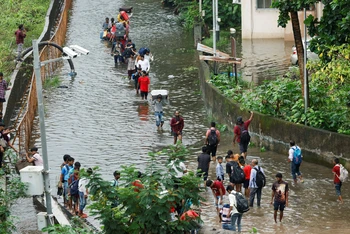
[199,61,350,169]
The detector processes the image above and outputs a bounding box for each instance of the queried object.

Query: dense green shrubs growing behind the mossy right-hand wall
[210,45,350,134]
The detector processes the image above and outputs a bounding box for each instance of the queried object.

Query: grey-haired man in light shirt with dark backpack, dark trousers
[249,159,266,207]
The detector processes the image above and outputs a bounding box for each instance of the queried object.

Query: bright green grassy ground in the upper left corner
[0,0,50,77]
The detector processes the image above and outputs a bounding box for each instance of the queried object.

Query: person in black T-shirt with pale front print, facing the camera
[271,173,289,223]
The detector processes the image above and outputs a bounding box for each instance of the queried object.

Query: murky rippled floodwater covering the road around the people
[9,0,350,234]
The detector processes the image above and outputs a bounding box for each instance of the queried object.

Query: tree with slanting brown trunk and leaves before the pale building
[272,0,318,96]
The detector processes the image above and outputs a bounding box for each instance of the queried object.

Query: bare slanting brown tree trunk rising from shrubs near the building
[290,11,304,97]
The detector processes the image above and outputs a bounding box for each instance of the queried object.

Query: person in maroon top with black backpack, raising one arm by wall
[233,111,254,159]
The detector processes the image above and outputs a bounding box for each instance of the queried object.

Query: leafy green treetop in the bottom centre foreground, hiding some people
[88,145,203,234]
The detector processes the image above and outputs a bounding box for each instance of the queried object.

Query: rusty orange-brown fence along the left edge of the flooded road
[12,0,72,152]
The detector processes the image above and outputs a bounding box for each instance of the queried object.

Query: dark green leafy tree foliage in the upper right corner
[305,0,350,61]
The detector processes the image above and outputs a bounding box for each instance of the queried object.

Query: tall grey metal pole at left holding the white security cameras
[33,40,53,226]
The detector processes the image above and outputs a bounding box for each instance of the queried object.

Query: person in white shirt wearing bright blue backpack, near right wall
[288,140,304,184]
